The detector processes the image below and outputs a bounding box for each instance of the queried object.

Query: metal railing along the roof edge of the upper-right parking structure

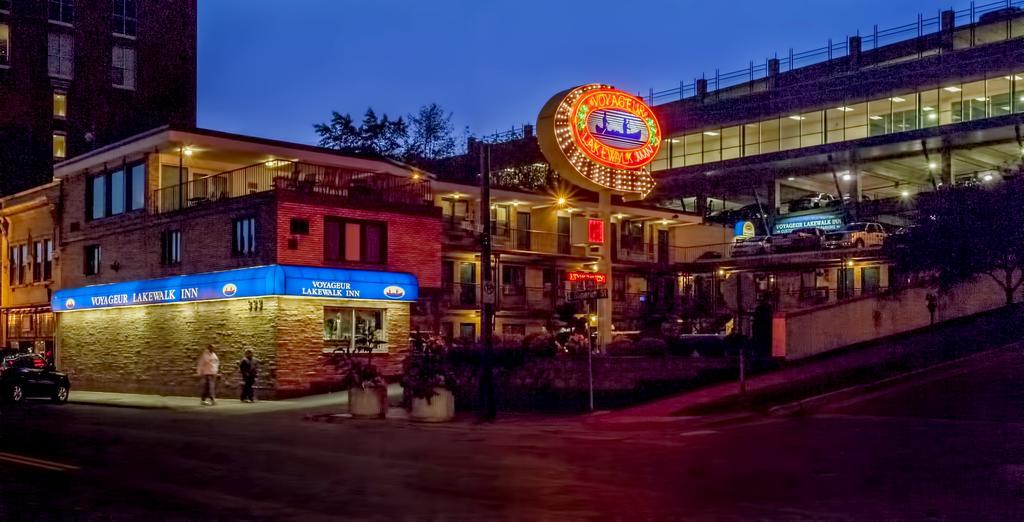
[637,0,1024,105]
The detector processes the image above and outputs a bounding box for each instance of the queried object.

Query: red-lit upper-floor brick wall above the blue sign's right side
[276,200,441,288]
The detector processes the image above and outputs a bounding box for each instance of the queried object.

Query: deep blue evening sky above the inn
[199,0,958,143]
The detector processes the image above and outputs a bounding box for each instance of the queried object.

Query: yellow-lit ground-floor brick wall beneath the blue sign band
[56,297,409,398]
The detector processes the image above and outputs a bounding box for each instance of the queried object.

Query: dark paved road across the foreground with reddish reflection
[0,343,1024,520]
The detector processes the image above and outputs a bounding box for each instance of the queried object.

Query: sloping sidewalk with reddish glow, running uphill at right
[588,306,1024,424]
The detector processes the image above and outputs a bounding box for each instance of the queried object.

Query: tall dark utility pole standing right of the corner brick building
[480,141,498,422]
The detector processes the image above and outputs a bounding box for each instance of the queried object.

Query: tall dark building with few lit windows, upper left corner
[0,0,197,194]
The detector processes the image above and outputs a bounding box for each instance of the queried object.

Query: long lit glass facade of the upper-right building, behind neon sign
[651,72,1024,171]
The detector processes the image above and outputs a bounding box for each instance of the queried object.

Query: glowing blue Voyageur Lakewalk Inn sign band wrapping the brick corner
[51,265,419,312]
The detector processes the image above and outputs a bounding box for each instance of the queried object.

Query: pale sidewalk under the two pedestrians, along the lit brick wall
[68,384,401,415]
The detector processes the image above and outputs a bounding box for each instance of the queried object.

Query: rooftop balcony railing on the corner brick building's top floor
[151,160,434,214]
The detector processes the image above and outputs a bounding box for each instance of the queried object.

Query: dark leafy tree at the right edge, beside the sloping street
[887,179,1024,305]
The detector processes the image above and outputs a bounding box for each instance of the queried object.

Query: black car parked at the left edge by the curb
[0,353,71,403]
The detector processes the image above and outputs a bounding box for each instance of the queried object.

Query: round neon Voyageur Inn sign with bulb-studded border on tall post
[537,84,662,194]
